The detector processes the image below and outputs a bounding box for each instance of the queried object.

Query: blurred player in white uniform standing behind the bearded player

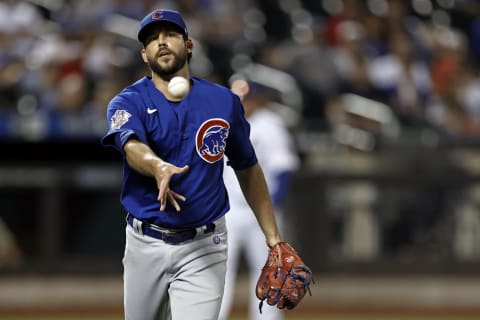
[219,79,299,320]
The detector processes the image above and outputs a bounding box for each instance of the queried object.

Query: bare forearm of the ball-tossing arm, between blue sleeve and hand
[123,139,165,177]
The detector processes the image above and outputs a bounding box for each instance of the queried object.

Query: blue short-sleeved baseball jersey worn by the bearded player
[102,77,257,228]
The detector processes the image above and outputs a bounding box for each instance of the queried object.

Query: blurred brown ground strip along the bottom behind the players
[0,275,480,320]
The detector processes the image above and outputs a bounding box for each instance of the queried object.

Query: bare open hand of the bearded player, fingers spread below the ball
[155,162,190,211]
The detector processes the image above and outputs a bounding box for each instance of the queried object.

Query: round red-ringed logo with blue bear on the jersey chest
[195,118,230,163]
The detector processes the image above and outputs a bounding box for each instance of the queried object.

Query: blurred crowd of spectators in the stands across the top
[0,0,480,139]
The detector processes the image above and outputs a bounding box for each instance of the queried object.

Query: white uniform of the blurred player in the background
[219,108,299,320]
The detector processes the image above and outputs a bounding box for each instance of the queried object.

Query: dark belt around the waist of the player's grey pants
[127,214,215,244]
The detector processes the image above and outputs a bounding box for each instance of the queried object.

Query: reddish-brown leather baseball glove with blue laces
[256,242,313,313]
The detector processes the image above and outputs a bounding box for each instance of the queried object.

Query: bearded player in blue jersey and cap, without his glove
[102,9,281,320]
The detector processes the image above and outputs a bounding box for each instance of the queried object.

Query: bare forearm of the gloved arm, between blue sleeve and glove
[235,164,281,246]
